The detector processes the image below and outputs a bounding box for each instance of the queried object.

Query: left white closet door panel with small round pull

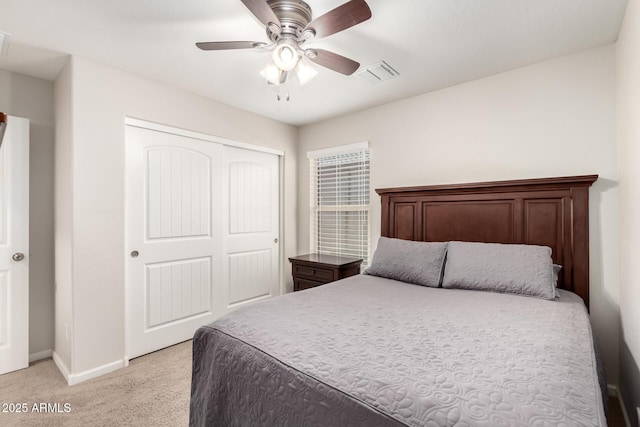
[125,126,225,358]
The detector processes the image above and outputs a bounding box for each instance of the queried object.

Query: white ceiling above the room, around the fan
[0,0,627,125]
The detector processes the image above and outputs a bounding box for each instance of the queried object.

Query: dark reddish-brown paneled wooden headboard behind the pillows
[376,175,598,307]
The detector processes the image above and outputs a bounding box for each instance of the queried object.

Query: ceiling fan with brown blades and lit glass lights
[196,0,371,85]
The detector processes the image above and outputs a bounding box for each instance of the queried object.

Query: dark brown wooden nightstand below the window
[289,254,362,291]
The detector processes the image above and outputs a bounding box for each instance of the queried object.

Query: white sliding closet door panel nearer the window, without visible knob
[223,146,280,308]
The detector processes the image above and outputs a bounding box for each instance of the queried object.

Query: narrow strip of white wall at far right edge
[616,0,640,426]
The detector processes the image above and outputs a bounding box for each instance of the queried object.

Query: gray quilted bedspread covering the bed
[190,275,606,426]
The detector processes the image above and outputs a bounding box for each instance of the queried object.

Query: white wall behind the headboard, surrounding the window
[298,45,619,384]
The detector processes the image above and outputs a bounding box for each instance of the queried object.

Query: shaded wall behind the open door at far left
[0,70,54,357]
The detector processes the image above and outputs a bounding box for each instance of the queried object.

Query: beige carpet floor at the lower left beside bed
[0,341,191,427]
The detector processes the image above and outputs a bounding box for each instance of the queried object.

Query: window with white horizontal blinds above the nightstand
[307,143,371,268]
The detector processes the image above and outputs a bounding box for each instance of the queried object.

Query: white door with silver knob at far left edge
[0,117,29,374]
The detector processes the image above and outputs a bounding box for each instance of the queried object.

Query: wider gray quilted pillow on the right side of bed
[442,242,555,300]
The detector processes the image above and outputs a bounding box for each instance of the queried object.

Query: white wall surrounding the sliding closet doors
[56,57,297,377]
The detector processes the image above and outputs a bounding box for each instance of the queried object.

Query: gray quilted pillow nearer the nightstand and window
[364,237,447,288]
